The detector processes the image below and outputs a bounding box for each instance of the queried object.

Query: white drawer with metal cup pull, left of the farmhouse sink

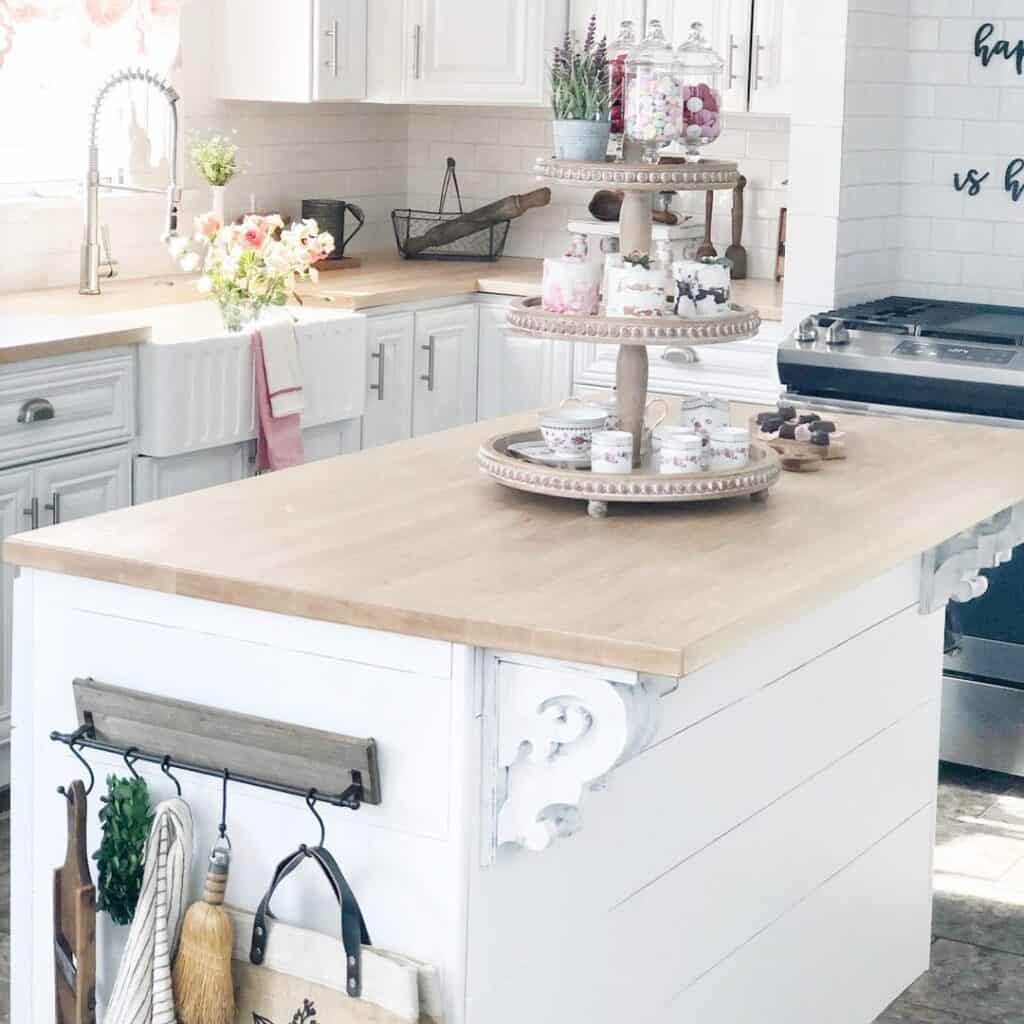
[0,351,135,466]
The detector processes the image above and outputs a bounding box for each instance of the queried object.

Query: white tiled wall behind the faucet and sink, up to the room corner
[0,2,408,291]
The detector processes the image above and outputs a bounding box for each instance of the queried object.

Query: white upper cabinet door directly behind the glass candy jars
[647,0,753,111]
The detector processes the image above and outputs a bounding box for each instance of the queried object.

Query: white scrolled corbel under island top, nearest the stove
[920,503,1024,614]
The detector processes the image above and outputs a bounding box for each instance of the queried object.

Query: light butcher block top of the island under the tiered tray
[4,407,1024,676]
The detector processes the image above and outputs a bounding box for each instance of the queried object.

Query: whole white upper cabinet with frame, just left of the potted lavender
[367,0,568,104]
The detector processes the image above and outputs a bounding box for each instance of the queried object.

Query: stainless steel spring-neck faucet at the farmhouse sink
[78,68,181,295]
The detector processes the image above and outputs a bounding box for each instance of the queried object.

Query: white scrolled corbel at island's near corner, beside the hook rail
[481,654,677,863]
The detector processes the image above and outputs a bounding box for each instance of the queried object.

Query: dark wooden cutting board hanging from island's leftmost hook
[53,779,96,1024]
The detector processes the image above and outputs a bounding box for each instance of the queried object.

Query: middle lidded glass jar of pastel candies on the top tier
[626,18,682,164]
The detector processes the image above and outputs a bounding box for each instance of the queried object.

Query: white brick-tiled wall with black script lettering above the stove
[837,0,1024,305]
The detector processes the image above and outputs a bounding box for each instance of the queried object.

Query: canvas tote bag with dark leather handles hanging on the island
[228,846,443,1024]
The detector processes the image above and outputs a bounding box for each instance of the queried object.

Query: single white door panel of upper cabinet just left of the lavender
[403,0,568,103]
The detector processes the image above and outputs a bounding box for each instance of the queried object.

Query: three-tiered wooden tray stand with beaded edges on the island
[478,159,780,517]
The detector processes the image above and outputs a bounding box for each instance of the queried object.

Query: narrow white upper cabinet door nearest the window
[312,0,367,100]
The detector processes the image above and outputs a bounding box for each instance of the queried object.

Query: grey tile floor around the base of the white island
[0,765,1024,1024]
